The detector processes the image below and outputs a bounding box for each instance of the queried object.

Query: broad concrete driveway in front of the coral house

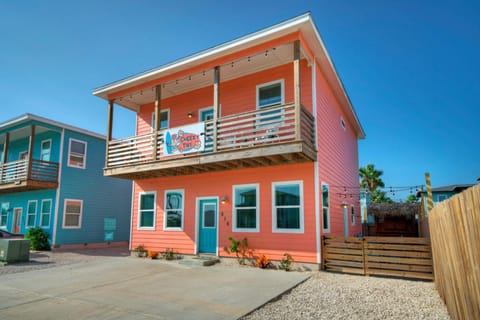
[0,257,309,320]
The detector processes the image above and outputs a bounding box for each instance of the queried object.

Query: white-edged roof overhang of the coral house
[93,13,365,139]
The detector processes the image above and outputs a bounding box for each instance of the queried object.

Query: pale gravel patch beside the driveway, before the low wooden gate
[242,272,450,320]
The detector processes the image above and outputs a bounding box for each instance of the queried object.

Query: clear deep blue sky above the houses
[0,0,480,198]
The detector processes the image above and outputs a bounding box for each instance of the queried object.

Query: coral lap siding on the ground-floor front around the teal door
[132,163,317,262]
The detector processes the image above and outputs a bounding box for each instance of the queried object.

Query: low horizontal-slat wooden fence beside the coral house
[322,236,433,280]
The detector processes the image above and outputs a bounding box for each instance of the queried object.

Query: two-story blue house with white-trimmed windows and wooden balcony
[0,114,132,248]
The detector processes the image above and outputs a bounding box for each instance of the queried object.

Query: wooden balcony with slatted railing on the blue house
[0,159,58,194]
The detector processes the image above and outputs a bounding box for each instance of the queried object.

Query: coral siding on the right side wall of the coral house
[316,63,361,236]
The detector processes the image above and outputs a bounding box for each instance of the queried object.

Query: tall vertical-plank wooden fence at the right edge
[428,185,480,319]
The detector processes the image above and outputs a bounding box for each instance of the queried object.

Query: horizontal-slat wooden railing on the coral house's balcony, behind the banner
[106,104,315,168]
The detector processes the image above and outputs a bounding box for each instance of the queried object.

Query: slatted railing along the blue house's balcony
[0,159,58,184]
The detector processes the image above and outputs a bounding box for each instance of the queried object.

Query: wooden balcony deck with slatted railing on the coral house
[104,104,316,179]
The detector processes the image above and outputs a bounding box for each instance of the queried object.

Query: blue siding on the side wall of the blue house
[56,130,131,245]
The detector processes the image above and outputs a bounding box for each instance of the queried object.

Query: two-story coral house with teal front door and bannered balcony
[94,14,364,263]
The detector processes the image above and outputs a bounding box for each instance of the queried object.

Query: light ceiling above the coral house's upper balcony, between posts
[115,43,303,111]
